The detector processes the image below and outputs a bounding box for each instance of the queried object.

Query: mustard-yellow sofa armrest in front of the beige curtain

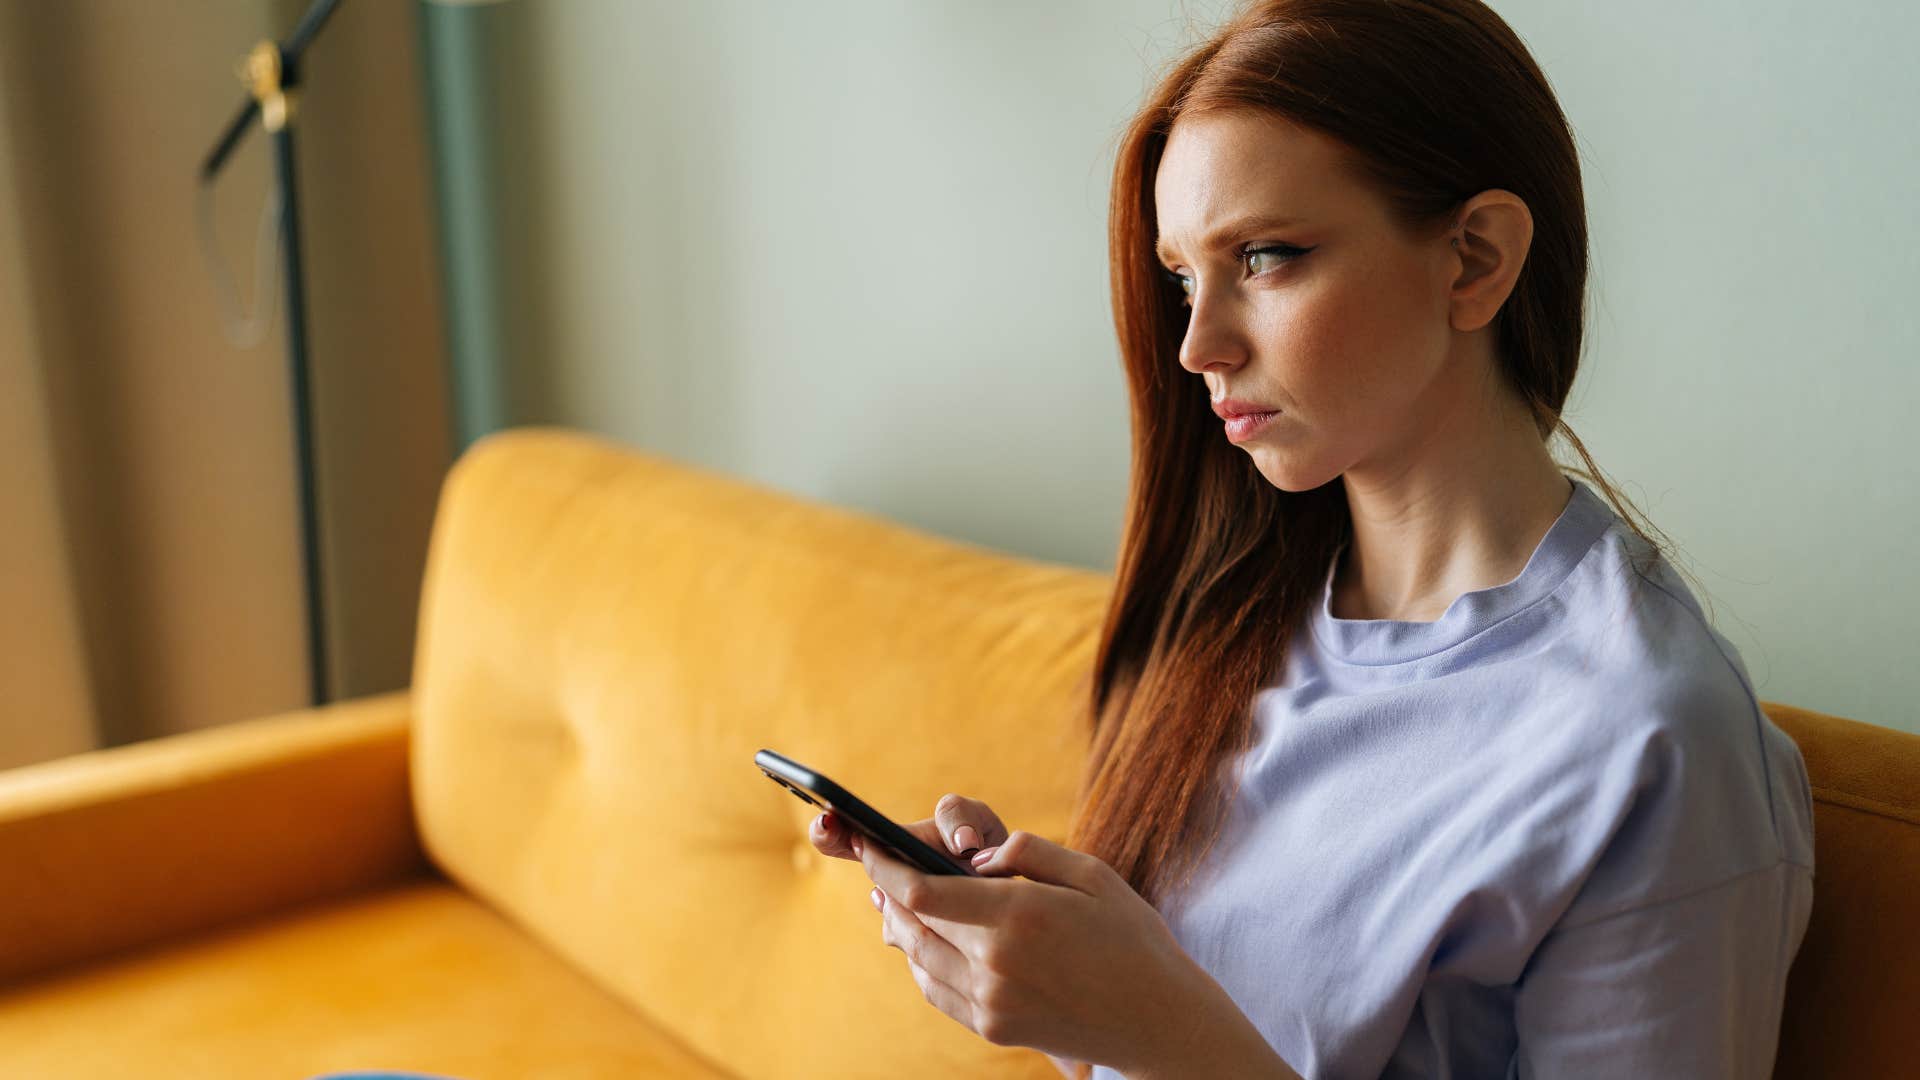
[0,690,428,982]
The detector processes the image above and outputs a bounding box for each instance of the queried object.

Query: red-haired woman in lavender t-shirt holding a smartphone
[812,0,1812,1078]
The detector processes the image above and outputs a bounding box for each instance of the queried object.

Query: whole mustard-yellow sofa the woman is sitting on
[0,429,1920,1080]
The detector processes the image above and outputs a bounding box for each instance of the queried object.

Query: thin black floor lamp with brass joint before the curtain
[200,0,340,705]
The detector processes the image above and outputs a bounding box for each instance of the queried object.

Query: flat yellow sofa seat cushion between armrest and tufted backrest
[0,878,726,1080]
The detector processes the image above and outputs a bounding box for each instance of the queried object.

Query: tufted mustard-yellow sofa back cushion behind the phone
[411,429,1112,1078]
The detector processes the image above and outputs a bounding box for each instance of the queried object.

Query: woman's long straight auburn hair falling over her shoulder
[1069,0,1661,953]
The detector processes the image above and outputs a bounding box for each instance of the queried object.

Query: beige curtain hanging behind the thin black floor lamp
[0,0,451,767]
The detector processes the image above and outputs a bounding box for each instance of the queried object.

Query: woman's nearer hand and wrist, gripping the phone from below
[858,830,1210,1072]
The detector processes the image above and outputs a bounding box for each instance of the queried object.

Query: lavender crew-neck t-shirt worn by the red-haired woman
[1094,479,1812,1080]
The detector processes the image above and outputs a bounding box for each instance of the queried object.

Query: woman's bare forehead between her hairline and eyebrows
[1154,110,1359,248]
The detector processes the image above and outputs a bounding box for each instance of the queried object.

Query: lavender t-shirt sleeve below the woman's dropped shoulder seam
[1507,861,1812,1080]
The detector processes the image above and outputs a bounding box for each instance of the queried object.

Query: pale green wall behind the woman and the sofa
[416,0,1920,730]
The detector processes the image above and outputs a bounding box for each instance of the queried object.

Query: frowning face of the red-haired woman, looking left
[1154,111,1482,492]
